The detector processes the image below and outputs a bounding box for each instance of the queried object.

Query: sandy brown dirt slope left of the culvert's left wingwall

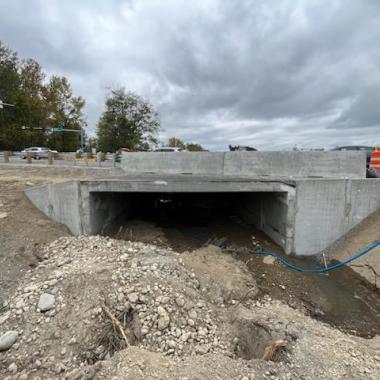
[0,165,116,305]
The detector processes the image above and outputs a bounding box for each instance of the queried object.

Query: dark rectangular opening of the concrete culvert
[91,192,288,251]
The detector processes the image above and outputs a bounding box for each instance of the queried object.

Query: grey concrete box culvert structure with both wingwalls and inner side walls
[25,176,380,255]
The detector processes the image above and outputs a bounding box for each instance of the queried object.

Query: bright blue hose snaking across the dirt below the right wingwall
[181,231,380,273]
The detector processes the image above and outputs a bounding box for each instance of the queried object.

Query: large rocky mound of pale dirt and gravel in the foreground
[0,236,380,380]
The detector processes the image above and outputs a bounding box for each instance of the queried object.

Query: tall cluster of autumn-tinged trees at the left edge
[0,41,86,151]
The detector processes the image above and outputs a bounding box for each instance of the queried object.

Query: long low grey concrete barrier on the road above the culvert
[121,151,366,179]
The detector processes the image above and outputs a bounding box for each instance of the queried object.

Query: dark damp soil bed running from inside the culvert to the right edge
[112,212,380,337]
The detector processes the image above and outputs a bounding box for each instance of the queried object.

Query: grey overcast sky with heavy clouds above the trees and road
[0,0,380,150]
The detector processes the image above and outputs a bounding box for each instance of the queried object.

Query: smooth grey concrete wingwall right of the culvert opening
[292,179,380,255]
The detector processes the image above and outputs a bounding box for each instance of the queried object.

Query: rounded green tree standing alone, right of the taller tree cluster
[97,88,160,152]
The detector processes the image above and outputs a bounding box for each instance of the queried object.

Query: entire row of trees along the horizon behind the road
[0,41,204,152]
